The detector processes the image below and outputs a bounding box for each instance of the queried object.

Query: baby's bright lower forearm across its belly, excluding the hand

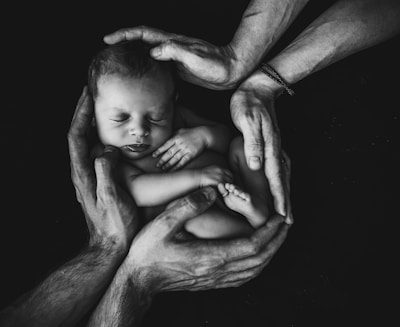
[129,169,200,207]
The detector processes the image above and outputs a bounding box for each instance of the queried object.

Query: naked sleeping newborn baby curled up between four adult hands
[89,41,272,238]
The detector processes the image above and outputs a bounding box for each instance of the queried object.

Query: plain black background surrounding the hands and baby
[0,0,400,326]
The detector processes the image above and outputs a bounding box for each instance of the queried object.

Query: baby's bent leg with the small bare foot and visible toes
[218,137,272,228]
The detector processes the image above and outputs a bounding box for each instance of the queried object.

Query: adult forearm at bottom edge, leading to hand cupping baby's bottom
[88,264,152,327]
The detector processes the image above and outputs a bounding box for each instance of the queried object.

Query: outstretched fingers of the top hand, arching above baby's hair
[103,26,174,44]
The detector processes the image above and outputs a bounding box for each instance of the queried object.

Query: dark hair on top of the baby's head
[88,41,171,98]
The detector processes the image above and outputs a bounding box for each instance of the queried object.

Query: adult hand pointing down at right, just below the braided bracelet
[230,71,293,223]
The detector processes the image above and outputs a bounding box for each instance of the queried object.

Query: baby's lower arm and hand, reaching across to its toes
[121,164,232,207]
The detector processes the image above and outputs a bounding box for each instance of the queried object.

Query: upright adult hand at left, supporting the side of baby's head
[68,87,138,251]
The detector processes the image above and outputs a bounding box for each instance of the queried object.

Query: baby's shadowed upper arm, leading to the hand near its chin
[178,107,231,154]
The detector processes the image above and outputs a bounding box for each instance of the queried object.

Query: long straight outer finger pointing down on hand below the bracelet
[262,117,286,216]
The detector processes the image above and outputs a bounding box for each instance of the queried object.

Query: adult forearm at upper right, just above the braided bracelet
[270,0,400,84]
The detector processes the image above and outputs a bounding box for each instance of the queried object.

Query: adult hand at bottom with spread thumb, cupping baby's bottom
[121,187,289,294]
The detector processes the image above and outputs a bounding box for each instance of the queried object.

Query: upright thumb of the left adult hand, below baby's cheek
[94,146,118,203]
